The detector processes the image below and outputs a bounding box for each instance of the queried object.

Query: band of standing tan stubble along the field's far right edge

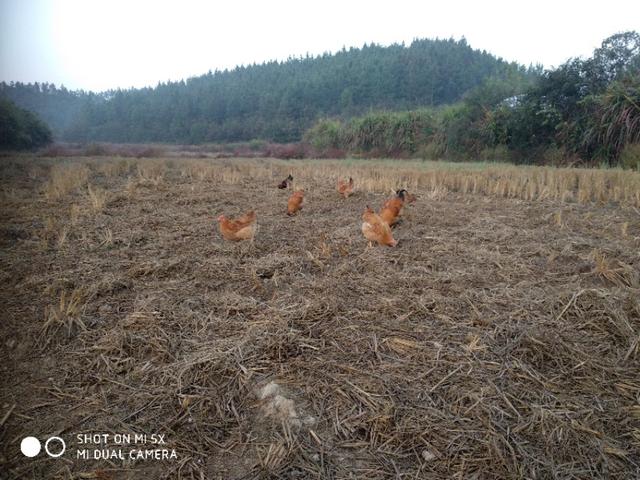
[156,159,640,207]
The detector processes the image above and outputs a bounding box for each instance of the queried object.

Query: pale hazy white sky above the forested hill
[0,0,640,91]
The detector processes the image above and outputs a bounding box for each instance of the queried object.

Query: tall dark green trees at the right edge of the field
[480,32,640,164]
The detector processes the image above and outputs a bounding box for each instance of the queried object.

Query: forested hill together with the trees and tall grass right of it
[0,32,640,168]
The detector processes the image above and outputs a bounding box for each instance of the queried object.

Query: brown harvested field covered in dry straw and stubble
[0,157,640,480]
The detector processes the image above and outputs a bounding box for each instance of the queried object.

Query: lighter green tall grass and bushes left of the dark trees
[305,69,531,160]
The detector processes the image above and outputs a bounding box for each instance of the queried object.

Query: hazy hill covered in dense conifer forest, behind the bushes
[0,39,533,143]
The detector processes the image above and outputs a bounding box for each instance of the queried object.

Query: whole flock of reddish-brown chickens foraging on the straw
[218,175,416,247]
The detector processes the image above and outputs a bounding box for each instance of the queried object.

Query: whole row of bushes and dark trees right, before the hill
[305,32,640,168]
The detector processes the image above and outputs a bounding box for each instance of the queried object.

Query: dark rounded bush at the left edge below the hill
[0,98,52,150]
